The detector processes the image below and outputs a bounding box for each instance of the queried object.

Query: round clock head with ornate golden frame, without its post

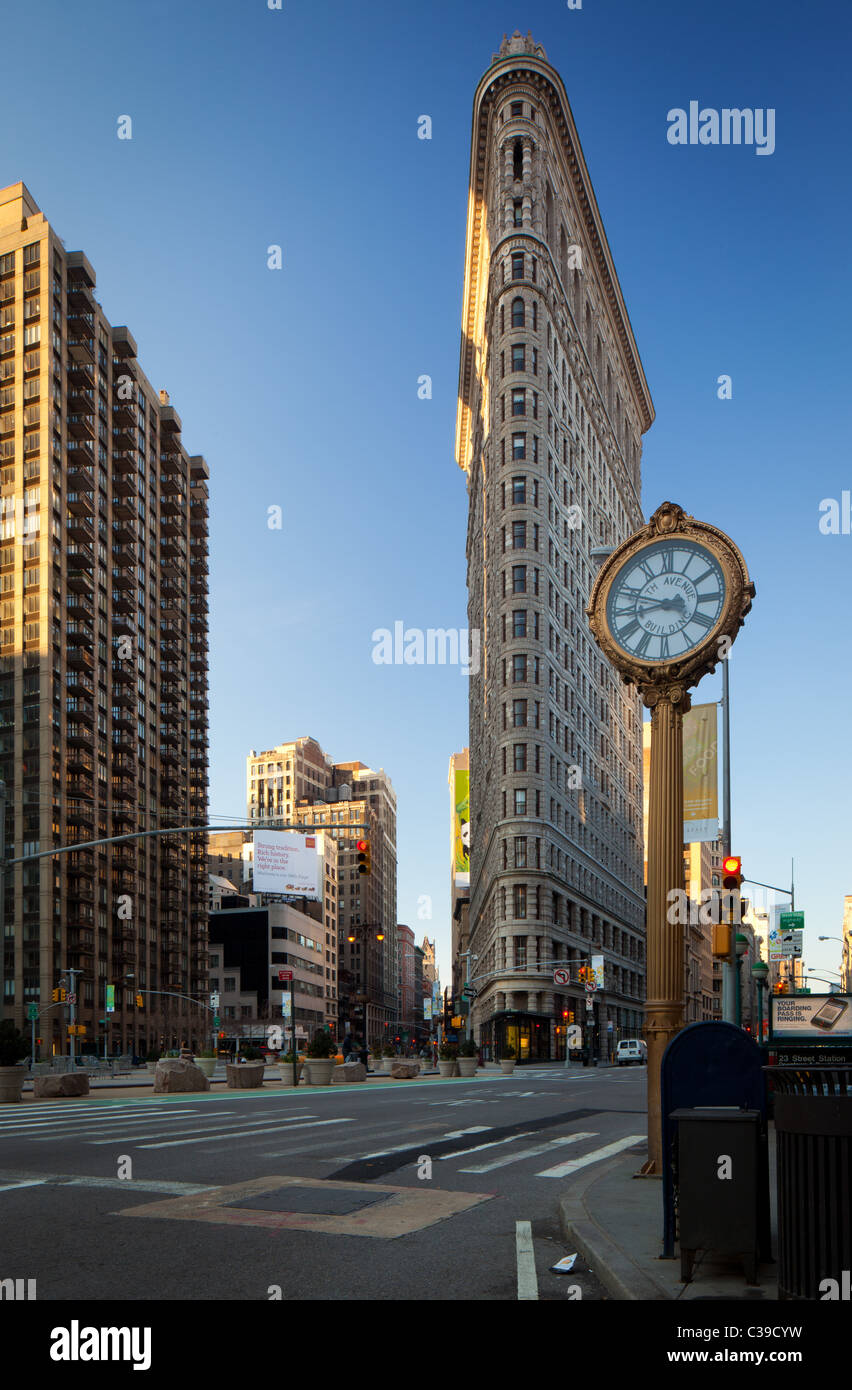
[587,502,755,688]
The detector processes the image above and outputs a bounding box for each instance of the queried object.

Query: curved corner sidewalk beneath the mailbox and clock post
[559,1125,778,1302]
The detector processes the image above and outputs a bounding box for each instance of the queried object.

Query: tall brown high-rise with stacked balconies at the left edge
[0,183,208,1056]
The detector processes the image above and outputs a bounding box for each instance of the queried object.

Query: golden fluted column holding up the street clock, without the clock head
[642,684,691,1173]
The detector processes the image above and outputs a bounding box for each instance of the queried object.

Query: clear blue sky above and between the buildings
[0,0,852,983]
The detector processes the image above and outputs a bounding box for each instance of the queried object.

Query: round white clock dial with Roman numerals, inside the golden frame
[606,537,726,662]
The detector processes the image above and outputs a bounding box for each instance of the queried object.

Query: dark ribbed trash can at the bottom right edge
[764,1066,852,1300]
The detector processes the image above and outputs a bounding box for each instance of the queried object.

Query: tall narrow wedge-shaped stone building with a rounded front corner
[456,33,653,1061]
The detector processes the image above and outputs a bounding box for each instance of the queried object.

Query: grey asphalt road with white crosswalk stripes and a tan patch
[0,1065,646,1301]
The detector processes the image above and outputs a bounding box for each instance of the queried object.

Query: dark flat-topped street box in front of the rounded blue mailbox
[669,1106,762,1284]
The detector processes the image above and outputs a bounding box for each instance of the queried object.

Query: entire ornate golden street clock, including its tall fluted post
[587,502,755,1176]
